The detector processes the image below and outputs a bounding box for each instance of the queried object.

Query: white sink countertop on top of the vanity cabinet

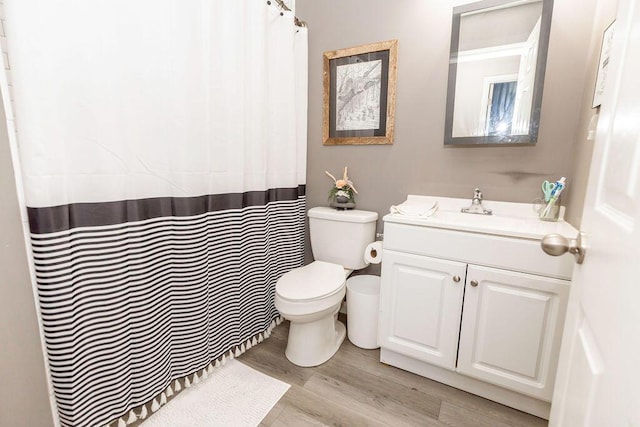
[383,195,578,240]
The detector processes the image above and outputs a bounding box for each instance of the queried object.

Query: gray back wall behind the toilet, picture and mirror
[296,0,597,244]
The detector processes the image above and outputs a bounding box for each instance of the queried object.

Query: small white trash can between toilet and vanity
[347,275,380,349]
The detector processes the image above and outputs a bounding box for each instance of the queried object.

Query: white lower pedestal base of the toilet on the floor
[284,307,347,368]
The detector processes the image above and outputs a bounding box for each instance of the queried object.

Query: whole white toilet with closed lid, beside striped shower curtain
[275,207,378,367]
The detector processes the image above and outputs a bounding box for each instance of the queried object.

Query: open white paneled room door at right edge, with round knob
[550,0,640,427]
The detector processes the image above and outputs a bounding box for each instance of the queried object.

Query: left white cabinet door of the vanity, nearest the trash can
[379,250,466,370]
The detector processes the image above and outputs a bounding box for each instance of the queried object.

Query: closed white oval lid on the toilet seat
[276,261,345,301]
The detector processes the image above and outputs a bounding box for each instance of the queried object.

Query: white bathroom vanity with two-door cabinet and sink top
[378,196,578,418]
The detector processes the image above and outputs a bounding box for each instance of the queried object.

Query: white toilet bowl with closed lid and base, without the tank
[275,261,346,367]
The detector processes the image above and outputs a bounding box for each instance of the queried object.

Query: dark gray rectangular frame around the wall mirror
[444,0,553,146]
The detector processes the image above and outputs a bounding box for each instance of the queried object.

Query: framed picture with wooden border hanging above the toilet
[322,40,398,145]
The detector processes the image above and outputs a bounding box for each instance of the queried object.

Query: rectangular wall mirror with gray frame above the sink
[444,0,553,145]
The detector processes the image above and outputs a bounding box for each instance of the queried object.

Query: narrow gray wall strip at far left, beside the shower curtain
[0,102,53,427]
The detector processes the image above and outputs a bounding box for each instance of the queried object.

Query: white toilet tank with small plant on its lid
[308,206,378,270]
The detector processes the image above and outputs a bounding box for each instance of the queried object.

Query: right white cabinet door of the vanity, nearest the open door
[457,265,569,401]
